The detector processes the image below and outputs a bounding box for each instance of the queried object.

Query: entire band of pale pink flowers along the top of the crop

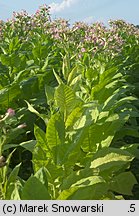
[0,5,139,60]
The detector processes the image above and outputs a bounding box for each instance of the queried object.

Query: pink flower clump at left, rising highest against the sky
[0,5,50,38]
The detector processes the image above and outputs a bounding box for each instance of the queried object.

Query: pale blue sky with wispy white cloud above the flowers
[0,0,139,25]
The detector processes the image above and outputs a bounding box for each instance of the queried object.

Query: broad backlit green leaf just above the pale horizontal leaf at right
[82,113,127,152]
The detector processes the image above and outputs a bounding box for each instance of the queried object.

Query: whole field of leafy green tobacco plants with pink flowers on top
[0,5,139,200]
